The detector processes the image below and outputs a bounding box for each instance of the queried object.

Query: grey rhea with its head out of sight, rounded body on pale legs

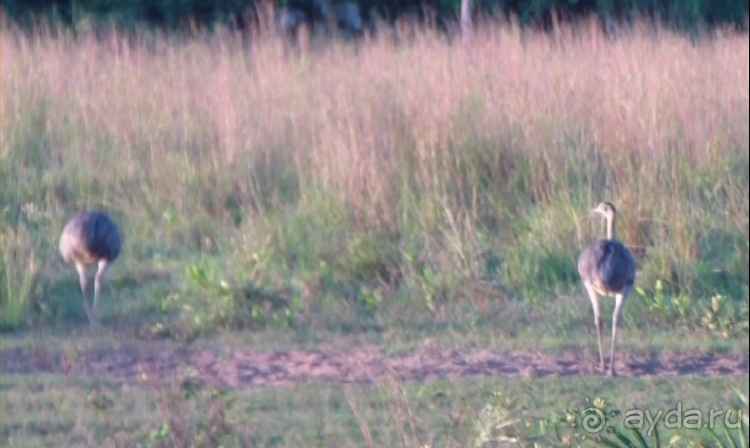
[60,211,121,324]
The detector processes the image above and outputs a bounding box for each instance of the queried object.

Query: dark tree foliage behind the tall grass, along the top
[0,0,749,31]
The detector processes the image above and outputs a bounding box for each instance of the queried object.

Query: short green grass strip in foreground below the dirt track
[2,375,748,447]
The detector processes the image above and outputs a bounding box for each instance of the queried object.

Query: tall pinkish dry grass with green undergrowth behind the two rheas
[0,17,750,326]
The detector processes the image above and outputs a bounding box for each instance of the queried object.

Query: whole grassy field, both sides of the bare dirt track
[0,14,750,446]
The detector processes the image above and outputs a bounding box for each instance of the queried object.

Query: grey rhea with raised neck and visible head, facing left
[578,202,636,376]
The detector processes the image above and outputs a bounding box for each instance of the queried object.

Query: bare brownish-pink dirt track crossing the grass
[0,348,748,388]
